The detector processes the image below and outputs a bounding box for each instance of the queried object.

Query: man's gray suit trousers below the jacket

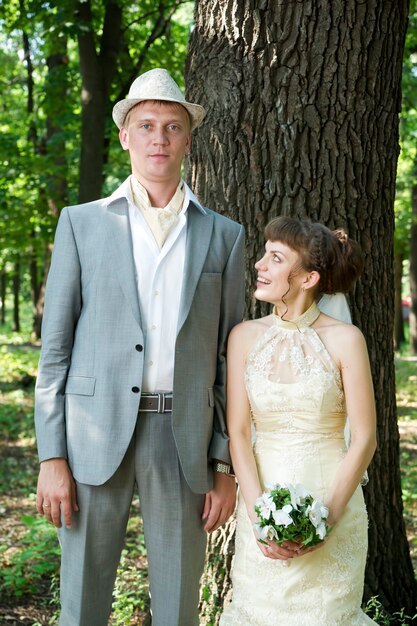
[59,413,206,626]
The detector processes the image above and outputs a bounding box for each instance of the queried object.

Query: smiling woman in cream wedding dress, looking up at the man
[220,217,376,626]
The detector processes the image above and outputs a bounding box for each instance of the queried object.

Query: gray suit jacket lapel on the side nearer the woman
[177,202,213,335]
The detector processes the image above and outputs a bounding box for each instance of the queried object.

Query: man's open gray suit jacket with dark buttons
[35,184,244,493]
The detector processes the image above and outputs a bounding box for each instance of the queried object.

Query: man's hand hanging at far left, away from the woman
[36,458,78,528]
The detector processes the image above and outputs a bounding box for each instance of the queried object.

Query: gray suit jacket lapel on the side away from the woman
[107,198,142,326]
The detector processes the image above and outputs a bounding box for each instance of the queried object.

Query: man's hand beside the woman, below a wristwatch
[201,472,236,533]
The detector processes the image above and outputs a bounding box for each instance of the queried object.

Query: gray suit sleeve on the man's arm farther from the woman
[35,209,81,461]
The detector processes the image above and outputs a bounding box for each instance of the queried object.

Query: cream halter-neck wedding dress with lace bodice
[220,304,375,626]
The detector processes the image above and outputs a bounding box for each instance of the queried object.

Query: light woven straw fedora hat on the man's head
[113,67,206,130]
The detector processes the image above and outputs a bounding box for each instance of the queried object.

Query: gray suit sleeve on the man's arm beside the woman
[209,226,245,464]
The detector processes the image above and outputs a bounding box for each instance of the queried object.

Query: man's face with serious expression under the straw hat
[119,100,191,187]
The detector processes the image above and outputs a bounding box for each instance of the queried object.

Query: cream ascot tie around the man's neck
[130,176,185,250]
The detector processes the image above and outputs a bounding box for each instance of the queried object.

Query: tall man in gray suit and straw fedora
[35,69,244,626]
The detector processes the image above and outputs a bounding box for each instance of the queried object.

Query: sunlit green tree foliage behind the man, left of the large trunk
[0,0,194,336]
